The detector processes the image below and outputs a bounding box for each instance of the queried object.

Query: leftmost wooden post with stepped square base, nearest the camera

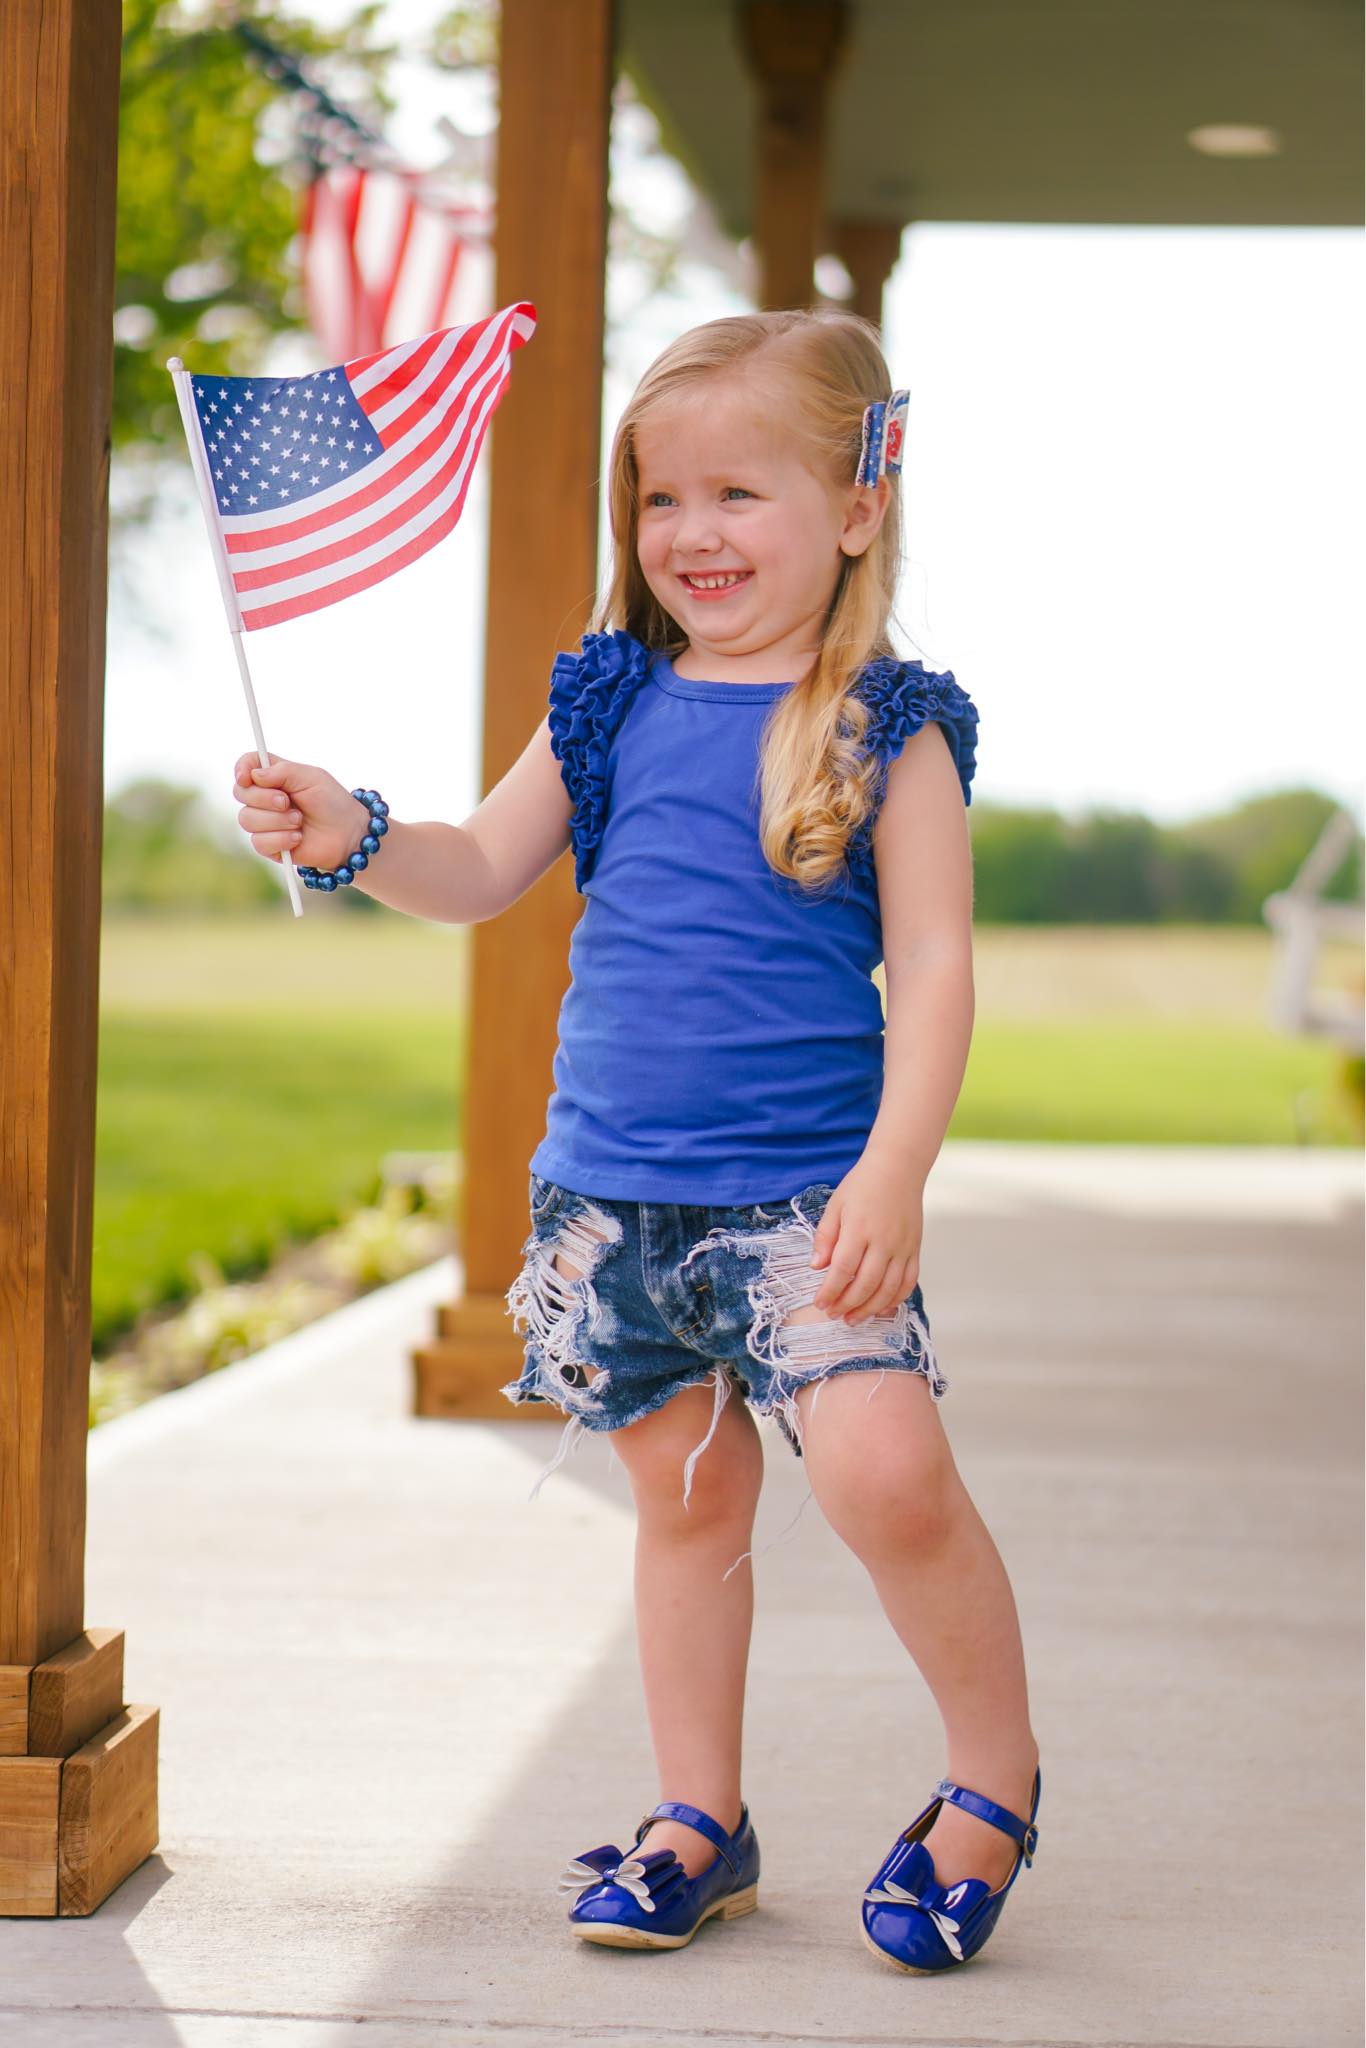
[0,0,158,1915]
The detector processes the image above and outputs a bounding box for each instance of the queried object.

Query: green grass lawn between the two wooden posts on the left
[92,907,465,1356]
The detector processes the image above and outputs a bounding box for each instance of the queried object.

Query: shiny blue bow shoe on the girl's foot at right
[862,1769,1040,1976]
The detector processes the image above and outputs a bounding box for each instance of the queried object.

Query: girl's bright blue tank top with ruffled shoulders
[530,633,977,1206]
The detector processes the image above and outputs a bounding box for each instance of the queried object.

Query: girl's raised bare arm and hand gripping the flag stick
[233,719,573,924]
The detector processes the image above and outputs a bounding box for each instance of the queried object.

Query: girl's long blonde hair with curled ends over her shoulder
[592,309,901,889]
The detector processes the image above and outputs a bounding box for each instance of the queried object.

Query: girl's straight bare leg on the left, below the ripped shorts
[612,1386,764,1876]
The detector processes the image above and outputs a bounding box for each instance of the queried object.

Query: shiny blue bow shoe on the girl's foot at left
[559,1798,760,1948]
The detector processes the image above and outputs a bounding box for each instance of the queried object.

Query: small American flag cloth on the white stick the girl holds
[188,301,537,633]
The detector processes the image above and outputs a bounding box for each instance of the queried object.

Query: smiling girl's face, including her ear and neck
[635,375,889,682]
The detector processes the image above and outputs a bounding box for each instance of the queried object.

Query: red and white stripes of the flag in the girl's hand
[221,301,537,633]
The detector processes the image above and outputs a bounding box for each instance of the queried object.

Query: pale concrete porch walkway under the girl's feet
[0,1143,1362,2048]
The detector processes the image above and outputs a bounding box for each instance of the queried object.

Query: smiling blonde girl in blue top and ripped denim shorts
[233,311,1040,1972]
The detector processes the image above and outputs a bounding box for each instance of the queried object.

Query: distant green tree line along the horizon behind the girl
[104,778,1362,924]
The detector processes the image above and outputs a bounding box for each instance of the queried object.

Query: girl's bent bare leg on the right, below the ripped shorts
[797,1359,1038,1888]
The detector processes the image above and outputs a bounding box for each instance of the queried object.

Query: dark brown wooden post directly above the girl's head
[739,0,848,309]
